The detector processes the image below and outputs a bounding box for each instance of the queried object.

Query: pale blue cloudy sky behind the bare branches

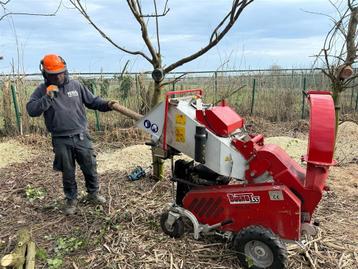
[0,0,334,73]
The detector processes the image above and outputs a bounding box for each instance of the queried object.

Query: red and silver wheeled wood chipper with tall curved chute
[137,89,335,268]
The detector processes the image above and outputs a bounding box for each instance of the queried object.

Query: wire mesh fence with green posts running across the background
[0,69,358,135]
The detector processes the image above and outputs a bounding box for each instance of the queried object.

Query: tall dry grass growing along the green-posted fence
[0,70,358,133]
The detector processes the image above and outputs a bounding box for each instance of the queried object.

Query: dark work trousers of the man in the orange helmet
[52,133,98,200]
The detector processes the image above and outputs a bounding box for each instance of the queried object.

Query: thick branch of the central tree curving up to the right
[164,0,253,73]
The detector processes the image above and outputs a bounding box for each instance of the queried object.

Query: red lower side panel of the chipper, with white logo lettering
[184,184,301,240]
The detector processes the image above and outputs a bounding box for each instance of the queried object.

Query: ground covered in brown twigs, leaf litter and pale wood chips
[0,120,358,269]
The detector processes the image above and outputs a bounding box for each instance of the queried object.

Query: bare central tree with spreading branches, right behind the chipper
[70,0,253,107]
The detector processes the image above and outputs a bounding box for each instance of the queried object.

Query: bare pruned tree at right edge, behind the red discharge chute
[316,0,358,133]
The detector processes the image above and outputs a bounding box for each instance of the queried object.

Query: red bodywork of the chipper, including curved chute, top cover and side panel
[183,91,335,240]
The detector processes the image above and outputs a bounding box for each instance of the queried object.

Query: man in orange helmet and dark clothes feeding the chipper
[26,54,116,215]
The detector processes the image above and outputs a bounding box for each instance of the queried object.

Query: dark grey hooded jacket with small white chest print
[26,74,111,136]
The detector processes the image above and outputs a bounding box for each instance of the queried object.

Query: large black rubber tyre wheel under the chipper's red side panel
[234,226,287,269]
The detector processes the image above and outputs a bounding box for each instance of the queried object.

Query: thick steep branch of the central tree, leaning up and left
[127,0,160,68]
